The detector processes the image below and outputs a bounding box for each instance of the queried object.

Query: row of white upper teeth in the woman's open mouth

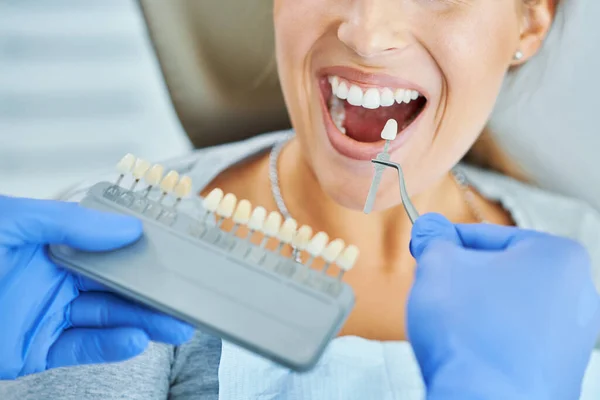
[329,76,421,109]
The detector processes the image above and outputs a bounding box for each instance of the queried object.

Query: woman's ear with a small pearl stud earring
[514,0,559,65]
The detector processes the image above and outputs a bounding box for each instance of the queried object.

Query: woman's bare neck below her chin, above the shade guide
[278,140,473,266]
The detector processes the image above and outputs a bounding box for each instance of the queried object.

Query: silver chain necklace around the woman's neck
[269,138,487,228]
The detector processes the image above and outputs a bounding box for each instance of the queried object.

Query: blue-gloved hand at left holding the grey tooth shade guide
[0,196,193,379]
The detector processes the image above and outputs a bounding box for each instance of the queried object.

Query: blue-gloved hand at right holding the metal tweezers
[407,214,600,400]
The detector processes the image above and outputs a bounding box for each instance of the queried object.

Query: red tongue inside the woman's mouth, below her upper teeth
[344,101,419,142]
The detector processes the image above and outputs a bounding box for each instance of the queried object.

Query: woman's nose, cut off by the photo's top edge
[337,0,410,59]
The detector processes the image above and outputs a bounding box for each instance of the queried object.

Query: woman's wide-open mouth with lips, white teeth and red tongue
[319,71,427,159]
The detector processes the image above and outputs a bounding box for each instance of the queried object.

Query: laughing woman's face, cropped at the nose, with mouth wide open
[274,0,544,209]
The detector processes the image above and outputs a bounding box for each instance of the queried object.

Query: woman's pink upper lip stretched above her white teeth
[318,66,429,99]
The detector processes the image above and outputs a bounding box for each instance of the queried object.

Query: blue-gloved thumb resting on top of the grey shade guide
[0,196,142,251]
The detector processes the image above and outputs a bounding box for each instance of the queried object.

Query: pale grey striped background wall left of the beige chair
[0,0,189,197]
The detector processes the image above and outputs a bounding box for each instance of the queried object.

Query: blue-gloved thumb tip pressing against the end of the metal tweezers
[410,213,462,260]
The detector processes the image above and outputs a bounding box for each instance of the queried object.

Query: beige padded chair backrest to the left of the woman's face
[139,0,289,147]
